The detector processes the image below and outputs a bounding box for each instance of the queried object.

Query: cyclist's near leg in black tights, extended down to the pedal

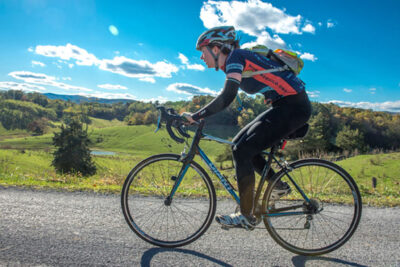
[217,95,311,229]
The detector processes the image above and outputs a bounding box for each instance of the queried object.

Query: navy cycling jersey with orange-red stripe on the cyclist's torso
[223,49,305,102]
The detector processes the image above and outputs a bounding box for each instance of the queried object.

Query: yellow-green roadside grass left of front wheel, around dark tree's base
[0,150,139,192]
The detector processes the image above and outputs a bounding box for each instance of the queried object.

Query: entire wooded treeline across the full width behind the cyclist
[0,91,400,155]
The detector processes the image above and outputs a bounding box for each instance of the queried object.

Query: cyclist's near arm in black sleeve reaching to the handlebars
[192,73,241,121]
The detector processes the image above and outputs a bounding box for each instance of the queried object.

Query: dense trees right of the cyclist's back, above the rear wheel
[285,103,400,156]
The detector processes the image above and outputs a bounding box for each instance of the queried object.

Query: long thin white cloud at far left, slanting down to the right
[8,71,92,92]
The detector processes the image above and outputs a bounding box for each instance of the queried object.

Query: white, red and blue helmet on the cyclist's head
[196,26,236,50]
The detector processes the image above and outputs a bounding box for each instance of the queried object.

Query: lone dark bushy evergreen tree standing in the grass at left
[52,120,96,176]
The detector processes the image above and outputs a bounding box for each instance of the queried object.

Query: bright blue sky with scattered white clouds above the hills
[0,0,400,112]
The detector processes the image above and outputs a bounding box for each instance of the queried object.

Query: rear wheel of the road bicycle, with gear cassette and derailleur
[262,159,362,256]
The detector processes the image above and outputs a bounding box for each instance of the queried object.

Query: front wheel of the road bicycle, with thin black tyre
[121,154,216,247]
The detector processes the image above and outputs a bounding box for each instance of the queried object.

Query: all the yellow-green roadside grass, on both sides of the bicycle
[0,150,400,206]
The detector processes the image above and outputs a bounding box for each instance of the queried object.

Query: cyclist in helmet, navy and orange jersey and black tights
[182,26,311,230]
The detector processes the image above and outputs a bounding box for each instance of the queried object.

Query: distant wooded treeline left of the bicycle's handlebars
[0,90,157,134]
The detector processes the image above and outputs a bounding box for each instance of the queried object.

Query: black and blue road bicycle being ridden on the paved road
[121,107,362,256]
